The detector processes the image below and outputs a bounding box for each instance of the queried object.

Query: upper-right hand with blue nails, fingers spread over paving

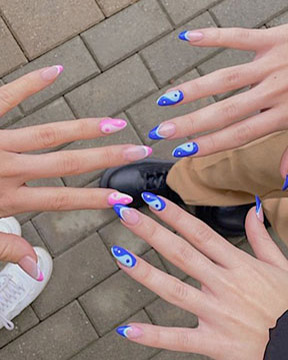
[150,25,288,187]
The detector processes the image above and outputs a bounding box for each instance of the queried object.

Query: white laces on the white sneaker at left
[0,275,24,331]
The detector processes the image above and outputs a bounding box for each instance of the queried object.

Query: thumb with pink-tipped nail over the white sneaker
[0,232,43,281]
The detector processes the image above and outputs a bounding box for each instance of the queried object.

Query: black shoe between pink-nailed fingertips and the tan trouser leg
[100,159,183,208]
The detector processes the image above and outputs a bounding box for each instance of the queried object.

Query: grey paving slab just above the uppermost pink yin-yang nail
[66,55,157,117]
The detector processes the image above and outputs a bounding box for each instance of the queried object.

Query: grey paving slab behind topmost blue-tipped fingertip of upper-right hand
[140,12,216,86]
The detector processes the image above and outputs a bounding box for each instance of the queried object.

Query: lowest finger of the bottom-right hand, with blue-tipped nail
[117,323,212,356]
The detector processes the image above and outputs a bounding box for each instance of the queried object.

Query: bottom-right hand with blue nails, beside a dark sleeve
[111,194,288,360]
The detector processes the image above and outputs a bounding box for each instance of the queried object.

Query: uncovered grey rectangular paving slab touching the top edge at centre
[82,0,172,70]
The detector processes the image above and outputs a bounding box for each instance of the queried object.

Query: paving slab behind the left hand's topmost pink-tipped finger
[4,36,100,113]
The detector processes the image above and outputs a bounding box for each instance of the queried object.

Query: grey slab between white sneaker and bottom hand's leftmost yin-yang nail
[33,234,117,319]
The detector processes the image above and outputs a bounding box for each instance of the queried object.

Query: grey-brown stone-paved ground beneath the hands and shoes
[0,0,288,360]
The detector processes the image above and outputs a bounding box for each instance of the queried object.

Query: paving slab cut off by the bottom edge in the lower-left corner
[0,301,97,360]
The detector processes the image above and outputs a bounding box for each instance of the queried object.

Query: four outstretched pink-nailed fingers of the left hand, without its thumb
[0,66,152,217]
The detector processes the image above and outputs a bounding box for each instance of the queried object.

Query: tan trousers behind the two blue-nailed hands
[167,131,288,244]
